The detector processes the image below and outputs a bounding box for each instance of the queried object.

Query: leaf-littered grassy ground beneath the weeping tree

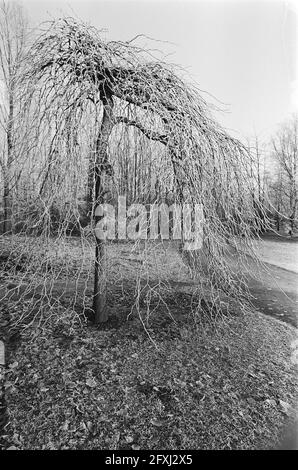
[1,233,298,449]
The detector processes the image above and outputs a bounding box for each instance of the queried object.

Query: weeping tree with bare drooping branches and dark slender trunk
[11,19,268,323]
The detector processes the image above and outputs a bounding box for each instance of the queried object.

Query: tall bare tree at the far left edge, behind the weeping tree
[0,1,27,232]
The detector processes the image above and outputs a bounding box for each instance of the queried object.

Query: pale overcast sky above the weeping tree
[22,0,298,142]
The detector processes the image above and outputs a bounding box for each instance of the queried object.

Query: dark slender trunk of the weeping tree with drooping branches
[93,96,113,324]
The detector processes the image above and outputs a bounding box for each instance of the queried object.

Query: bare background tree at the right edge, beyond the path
[272,115,298,235]
